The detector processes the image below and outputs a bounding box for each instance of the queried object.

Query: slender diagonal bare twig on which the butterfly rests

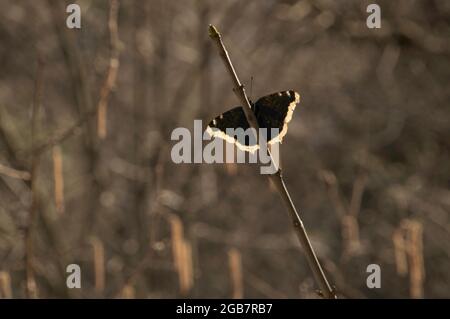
[209,25,336,299]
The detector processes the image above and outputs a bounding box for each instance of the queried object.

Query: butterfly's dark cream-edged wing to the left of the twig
[206,106,259,153]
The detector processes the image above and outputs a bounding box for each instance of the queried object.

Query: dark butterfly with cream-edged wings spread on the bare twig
[206,90,300,153]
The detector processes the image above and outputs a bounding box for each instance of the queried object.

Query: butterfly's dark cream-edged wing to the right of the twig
[253,90,300,144]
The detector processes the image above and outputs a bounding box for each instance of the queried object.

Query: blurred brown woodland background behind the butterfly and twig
[0,0,450,298]
